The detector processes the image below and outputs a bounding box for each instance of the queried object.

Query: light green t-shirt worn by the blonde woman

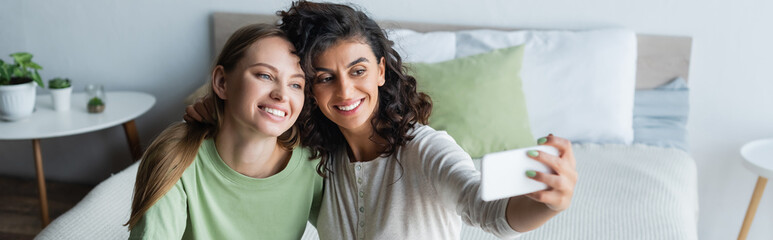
[129,139,322,239]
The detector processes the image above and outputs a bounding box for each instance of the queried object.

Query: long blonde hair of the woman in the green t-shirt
[124,24,300,230]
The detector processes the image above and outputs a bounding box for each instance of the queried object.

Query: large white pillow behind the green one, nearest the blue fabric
[456,29,637,144]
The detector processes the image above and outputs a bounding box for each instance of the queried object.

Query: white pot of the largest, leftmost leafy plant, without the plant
[0,81,38,121]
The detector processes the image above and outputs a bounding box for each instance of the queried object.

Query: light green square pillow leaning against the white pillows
[408,46,536,158]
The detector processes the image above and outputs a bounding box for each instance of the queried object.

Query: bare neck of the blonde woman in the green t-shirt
[215,120,292,178]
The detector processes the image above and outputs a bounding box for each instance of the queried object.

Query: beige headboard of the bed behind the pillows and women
[212,13,692,89]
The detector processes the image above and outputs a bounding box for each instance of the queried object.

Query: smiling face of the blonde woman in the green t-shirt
[213,37,305,136]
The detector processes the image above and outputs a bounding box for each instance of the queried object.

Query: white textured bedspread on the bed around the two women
[36,144,698,239]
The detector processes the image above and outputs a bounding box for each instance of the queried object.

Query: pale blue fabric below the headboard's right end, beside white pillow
[633,77,690,151]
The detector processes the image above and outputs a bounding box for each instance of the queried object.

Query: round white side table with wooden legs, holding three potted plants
[0,92,156,227]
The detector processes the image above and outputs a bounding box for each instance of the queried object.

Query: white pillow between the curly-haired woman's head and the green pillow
[386,29,456,63]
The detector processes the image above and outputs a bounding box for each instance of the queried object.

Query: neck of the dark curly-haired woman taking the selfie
[339,124,386,162]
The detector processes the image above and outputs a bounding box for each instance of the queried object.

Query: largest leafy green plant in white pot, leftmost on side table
[0,52,43,121]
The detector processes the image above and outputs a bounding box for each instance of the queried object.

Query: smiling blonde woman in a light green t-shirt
[127,24,322,239]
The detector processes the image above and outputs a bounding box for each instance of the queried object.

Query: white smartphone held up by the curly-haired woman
[480,145,558,201]
